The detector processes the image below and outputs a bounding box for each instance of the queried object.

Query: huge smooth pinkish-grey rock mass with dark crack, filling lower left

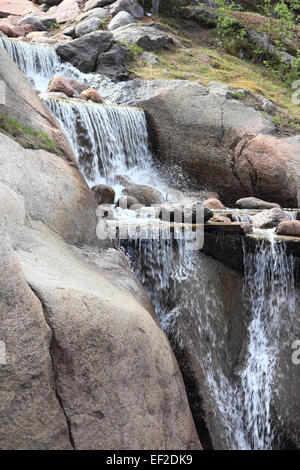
[0,146,200,450]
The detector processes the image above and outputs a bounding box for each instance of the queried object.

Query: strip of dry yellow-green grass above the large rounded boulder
[129,36,300,129]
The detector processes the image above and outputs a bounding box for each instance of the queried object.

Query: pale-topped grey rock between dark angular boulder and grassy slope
[113,23,169,51]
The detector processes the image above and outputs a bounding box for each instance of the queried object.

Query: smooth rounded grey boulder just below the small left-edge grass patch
[0,130,97,243]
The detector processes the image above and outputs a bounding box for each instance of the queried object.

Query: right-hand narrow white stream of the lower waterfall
[240,232,296,449]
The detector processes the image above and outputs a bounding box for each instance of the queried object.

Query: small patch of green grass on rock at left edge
[0,116,61,155]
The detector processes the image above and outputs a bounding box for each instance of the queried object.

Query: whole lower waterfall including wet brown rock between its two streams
[124,231,299,449]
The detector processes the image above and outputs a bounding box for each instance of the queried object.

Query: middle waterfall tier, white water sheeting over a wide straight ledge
[45,99,153,185]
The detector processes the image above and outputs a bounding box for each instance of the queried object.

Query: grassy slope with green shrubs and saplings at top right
[127,0,300,133]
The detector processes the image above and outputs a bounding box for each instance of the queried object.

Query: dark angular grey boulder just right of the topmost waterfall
[56,31,114,72]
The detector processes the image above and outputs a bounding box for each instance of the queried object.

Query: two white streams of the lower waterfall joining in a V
[121,233,296,450]
